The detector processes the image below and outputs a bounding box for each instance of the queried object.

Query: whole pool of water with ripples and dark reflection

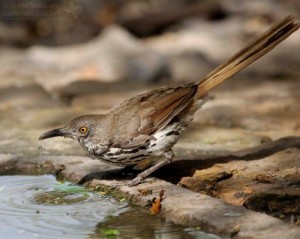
[0,175,218,239]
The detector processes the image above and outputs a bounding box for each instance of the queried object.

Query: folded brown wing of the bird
[111,84,198,147]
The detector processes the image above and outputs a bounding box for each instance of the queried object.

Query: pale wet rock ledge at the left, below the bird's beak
[0,153,118,183]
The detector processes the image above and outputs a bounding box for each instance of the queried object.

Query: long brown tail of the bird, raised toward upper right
[195,17,300,98]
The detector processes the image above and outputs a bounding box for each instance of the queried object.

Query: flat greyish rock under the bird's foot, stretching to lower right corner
[88,179,300,239]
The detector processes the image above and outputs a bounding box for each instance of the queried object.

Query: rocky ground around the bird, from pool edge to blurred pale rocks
[0,8,300,238]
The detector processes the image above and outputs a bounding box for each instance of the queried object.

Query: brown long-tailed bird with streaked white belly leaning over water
[39,16,300,186]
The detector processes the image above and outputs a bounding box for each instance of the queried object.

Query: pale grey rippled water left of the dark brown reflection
[0,175,128,238]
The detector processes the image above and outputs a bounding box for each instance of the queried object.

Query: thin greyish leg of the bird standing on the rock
[128,150,174,186]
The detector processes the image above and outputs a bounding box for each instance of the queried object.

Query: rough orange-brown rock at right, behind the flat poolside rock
[180,149,300,220]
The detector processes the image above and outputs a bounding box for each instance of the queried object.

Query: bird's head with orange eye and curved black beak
[39,115,101,140]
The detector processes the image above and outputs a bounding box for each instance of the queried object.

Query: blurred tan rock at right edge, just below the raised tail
[195,78,300,140]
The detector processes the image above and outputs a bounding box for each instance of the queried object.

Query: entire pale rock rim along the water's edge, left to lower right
[0,154,300,239]
